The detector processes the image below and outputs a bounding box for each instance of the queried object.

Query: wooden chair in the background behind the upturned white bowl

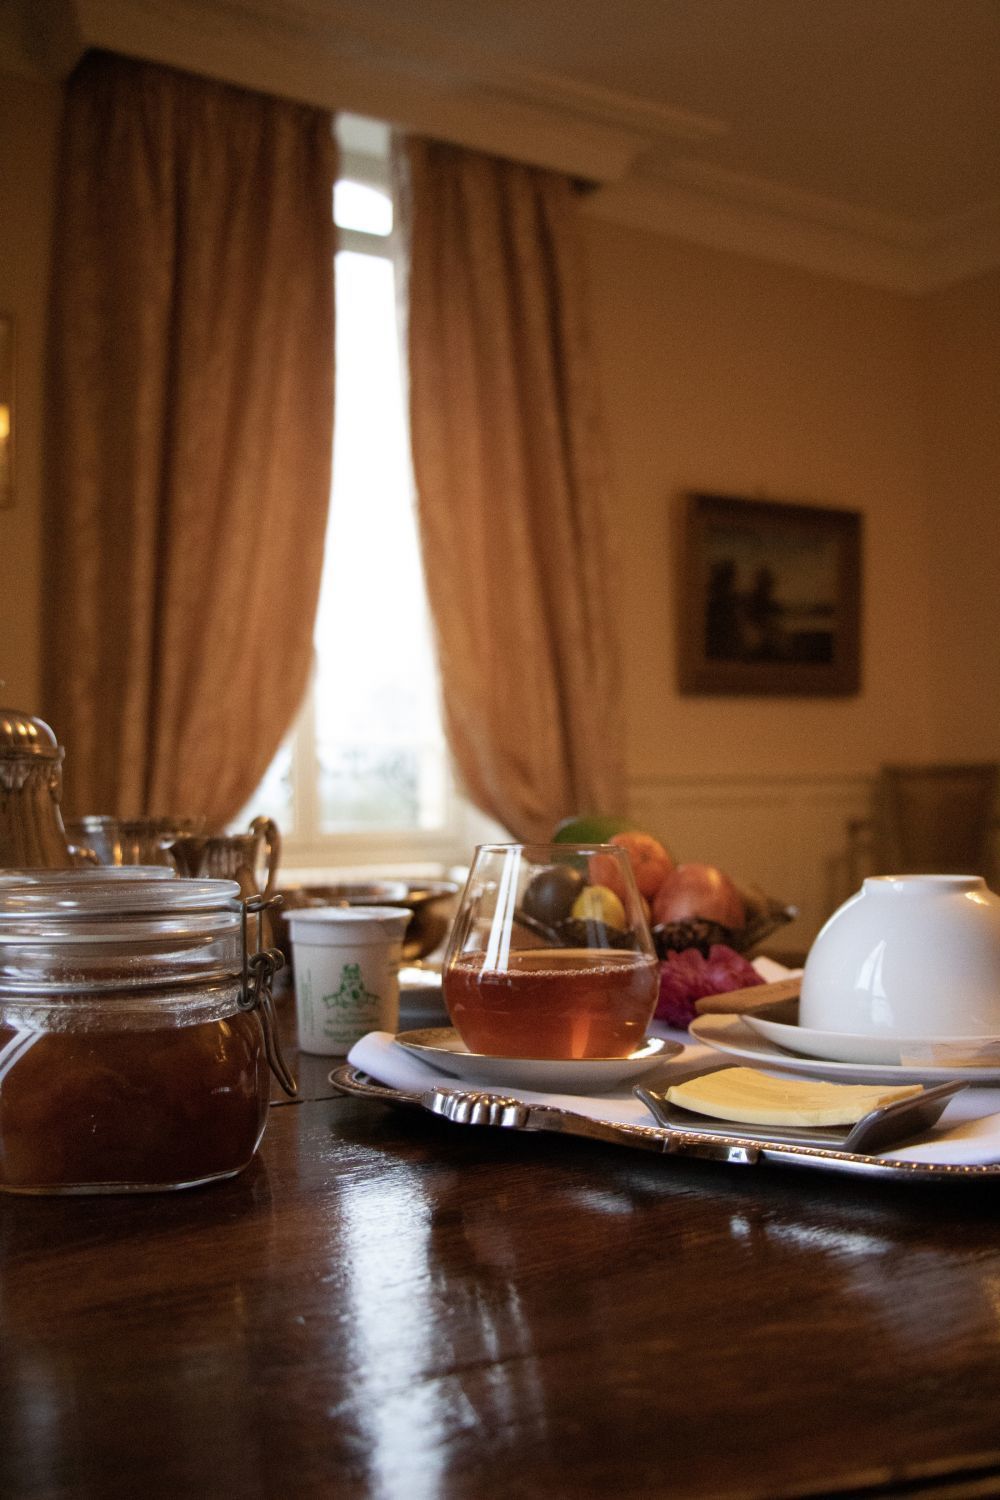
[847,761,1000,890]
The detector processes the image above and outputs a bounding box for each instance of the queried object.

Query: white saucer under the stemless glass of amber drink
[396,1026,684,1094]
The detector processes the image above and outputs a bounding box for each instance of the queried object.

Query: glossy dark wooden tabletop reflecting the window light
[0,996,1000,1500]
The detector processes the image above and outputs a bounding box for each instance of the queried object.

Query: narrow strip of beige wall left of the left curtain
[0,74,60,708]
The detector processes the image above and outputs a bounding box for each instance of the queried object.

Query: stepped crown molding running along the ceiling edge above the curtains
[9,0,1000,296]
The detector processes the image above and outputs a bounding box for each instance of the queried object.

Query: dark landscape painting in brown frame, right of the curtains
[679,494,862,695]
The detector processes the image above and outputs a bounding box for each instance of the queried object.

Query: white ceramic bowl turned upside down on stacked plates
[799,875,1000,1038]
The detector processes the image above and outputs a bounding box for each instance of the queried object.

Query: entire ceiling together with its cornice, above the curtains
[7,0,1000,293]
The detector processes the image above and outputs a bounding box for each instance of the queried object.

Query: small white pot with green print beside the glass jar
[286,906,412,1058]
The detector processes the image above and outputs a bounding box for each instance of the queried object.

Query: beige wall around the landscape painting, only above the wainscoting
[589,222,933,777]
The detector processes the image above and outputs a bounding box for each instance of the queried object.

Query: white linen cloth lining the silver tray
[348,1023,1000,1166]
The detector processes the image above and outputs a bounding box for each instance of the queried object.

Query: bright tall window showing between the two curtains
[240,117,496,869]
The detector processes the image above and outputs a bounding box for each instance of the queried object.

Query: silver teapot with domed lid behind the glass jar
[0,708,78,870]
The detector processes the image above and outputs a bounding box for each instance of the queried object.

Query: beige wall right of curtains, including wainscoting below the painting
[578,219,971,924]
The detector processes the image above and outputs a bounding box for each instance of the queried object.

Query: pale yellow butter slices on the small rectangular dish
[664,1068,922,1125]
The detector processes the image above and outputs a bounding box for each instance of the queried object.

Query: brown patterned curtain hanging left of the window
[45,53,336,825]
